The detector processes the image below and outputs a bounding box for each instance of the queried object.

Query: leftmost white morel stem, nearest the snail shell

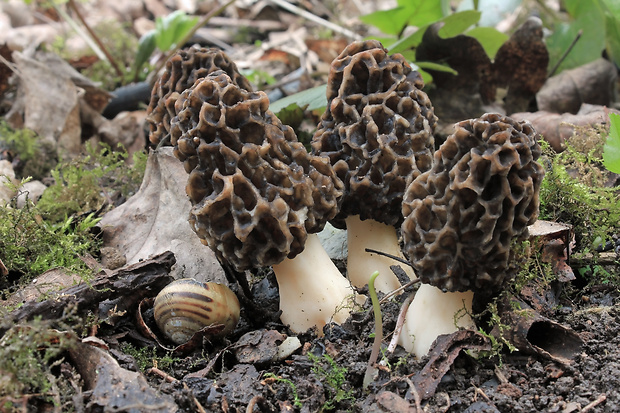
[272,234,358,335]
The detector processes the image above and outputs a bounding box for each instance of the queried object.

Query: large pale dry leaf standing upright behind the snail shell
[99,147,226,283]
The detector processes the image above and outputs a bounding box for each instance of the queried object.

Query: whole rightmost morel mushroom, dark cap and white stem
[399,114,544,357]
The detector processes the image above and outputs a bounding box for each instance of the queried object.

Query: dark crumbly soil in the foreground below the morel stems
[124,268,620,413]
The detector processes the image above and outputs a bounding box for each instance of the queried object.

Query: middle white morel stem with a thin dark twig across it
[345,215,416,293]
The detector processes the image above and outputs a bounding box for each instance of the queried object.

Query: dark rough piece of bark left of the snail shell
[0,251,175,336]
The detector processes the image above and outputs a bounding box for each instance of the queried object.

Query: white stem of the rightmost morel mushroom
[398,284,476,359]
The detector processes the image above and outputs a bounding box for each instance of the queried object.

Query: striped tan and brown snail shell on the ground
[153,278,239,344]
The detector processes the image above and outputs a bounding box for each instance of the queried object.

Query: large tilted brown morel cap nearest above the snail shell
[171,71,343,271]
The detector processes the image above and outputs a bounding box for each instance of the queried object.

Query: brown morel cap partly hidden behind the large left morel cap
[146,47,252,145]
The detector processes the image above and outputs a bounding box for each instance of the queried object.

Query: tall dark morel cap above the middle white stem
[312,40,437,228]
